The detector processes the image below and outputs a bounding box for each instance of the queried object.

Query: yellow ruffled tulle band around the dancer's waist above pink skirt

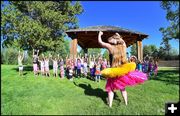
[101,62,136,78]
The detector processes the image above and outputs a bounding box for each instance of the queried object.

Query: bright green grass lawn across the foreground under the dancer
[1,65,179,115]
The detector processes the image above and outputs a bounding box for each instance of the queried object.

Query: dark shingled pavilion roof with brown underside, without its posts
[66,26,148,48]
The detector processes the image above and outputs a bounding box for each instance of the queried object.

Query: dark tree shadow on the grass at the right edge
[150,70,179,85]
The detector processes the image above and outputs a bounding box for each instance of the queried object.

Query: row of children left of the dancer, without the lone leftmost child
[33,50,110,82]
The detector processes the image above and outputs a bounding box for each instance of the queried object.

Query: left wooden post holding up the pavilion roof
[70,38,77,59]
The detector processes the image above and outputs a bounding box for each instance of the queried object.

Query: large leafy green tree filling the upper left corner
[1,1,83,52]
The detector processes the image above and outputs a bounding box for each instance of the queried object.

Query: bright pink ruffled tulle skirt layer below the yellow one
[106,70,147,92]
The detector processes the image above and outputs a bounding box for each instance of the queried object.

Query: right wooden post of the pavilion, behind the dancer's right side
[136,41,143,61]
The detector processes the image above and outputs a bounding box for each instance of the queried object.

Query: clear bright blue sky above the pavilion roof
[73,1,179,51]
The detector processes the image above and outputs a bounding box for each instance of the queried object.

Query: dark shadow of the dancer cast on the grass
[73,82,121,104]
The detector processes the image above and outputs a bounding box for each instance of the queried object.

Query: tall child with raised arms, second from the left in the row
[33,49,39,75]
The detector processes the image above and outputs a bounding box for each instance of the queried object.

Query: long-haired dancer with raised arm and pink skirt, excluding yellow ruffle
[98,32,147,107]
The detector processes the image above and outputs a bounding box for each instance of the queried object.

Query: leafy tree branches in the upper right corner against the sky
[159,1,179,44]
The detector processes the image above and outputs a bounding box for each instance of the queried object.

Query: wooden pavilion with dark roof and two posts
[66,26,148,60]
